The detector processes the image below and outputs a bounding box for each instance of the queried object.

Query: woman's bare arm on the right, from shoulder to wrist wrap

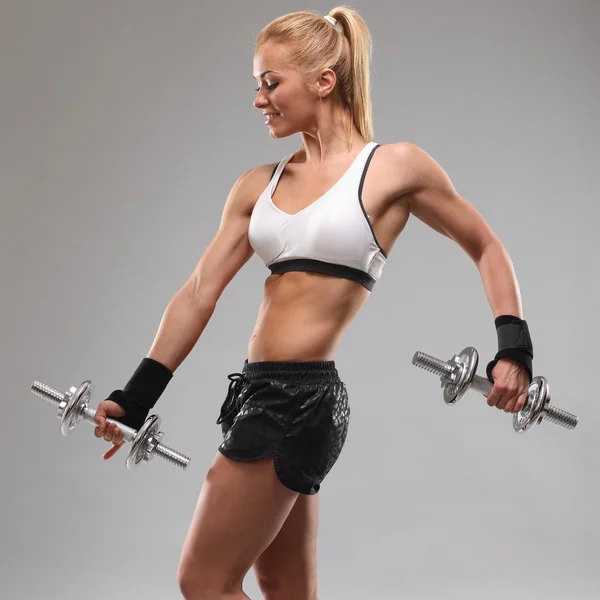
[393,143,522,318]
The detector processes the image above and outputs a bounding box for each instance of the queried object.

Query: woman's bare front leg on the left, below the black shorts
[178,453,298,600]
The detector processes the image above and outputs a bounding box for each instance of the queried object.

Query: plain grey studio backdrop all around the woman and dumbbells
[0,0,600,600]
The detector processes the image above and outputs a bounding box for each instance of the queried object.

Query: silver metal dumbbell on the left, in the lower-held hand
[31,381,190,469]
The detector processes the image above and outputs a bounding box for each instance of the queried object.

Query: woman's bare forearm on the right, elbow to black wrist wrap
[477,241,523,319]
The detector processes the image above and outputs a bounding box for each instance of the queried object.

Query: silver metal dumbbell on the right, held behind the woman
[412,346,579,433]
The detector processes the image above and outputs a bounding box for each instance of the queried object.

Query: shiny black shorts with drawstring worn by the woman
[217,360,350,495]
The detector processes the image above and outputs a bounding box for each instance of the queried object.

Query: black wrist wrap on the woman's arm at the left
[108,358,173,430]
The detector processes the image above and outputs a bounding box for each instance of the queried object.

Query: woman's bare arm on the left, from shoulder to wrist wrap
[148,167,264,372]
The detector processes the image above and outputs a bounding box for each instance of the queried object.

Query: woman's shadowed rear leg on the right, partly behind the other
[254,494,319,600]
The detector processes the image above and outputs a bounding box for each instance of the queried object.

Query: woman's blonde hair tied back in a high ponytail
[254,6,373,147]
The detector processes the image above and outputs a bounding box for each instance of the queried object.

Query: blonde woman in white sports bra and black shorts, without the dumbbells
[95,7,533,600]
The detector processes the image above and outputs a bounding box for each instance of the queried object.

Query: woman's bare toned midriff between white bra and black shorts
[248,272,370,362]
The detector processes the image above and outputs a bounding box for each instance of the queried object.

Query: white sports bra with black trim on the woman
[248,142,387,290]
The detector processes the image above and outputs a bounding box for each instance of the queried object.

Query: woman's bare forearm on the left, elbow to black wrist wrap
[148,288,216,372]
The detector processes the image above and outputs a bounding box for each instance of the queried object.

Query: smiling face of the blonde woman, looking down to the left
[253,43,330,138]
